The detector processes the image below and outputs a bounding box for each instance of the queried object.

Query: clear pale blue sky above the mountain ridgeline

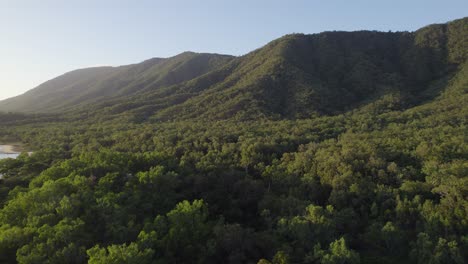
[0,0,468,99]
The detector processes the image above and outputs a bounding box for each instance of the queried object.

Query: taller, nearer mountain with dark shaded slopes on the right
[152,16,468,119]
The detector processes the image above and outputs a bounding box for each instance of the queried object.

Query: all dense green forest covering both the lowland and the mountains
[0,18,468,264]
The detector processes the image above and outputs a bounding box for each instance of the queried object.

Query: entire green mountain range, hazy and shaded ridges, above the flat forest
[0,18,468,121]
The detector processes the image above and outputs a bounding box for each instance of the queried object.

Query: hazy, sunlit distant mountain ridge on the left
[0,52,232,112]
